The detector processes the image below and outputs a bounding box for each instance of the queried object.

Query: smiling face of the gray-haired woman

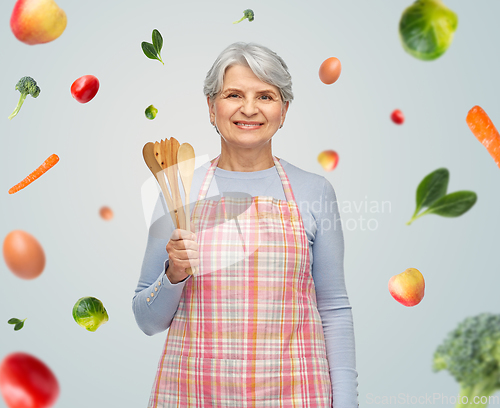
[207,65,288,152]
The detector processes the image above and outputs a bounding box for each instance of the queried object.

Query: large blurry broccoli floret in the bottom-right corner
[432,313,500,408]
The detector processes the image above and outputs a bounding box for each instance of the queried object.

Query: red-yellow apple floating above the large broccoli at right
[389,268,425,306]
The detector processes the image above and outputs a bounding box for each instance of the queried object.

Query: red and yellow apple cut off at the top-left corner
[10,0,67,45]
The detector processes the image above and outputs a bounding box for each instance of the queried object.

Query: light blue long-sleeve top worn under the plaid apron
[132,159,358,408]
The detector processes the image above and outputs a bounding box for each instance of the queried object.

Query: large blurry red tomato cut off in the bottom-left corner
[0,352,59,408]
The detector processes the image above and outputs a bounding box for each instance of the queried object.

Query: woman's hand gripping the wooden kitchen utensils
[167,229,200,283]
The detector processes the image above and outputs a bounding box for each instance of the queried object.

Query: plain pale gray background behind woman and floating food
[0,0,500,408]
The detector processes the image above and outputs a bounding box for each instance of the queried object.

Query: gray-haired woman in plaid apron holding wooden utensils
[133,43,358,408]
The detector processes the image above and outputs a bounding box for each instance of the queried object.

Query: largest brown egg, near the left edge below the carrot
[3,230,45,279]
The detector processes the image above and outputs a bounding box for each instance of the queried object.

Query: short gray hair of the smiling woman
[203,42,293,103]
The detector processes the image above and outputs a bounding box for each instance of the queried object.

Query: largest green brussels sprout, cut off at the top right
[399,0,458,61]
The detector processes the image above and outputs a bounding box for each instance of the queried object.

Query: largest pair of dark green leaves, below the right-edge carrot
[406,168,477,225]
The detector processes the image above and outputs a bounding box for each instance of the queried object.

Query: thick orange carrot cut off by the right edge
[466,105,500,167]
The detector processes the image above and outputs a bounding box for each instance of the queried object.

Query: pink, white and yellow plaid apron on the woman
[148,156,332,408]
